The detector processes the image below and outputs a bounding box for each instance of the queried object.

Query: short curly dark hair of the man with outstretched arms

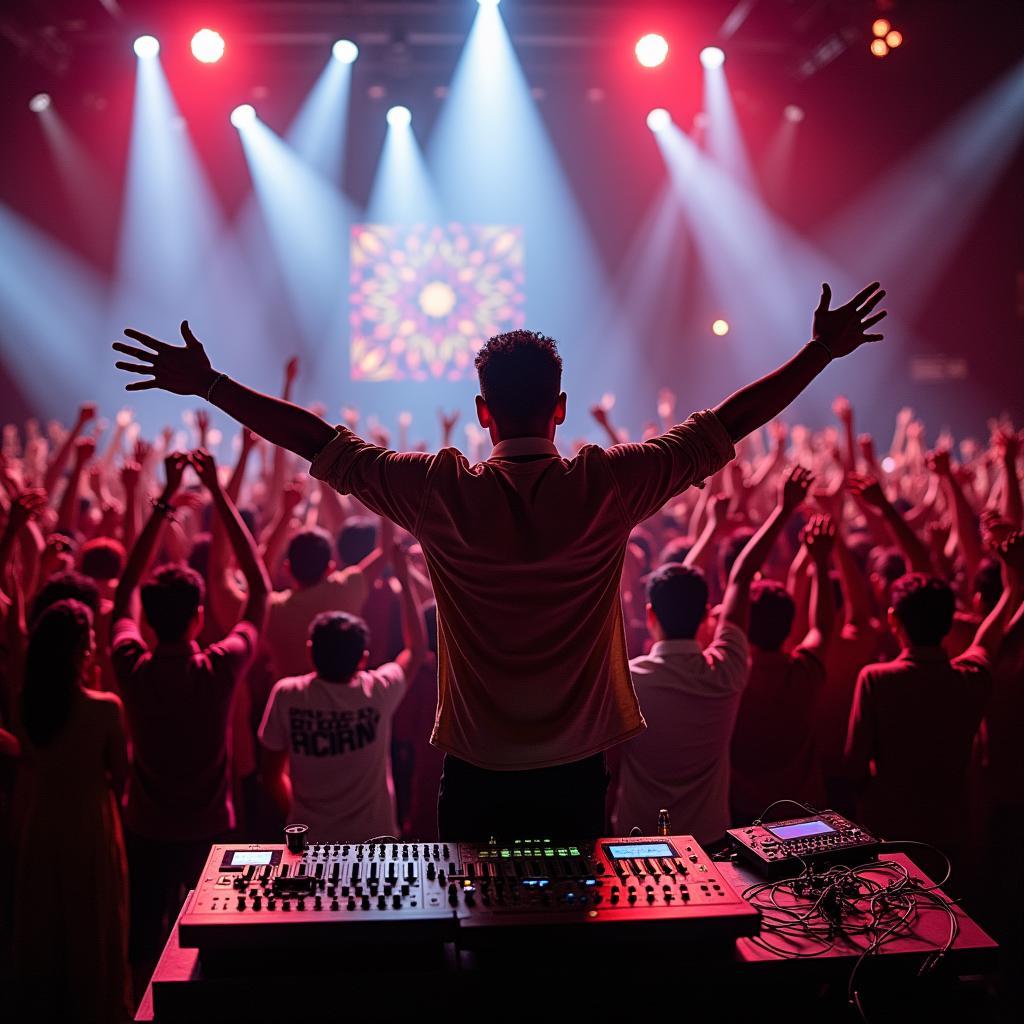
[476,331,562,428]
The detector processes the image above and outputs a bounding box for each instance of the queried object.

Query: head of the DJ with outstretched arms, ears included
[476,331,565,443]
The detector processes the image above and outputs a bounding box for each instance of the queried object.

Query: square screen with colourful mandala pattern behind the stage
[349,224,526,381]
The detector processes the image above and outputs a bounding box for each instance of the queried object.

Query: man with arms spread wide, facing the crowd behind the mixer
[114,284,885,839]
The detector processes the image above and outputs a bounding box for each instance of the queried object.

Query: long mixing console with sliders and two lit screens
[179,836,759,950]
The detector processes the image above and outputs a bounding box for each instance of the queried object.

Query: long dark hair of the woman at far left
[22,598,95,746]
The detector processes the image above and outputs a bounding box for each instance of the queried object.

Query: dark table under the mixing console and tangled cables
[135,853,997,1024]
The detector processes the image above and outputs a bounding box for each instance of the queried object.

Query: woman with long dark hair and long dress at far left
[13,600,131,1021]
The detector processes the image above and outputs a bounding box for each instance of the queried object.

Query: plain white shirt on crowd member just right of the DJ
[612,621,750,843]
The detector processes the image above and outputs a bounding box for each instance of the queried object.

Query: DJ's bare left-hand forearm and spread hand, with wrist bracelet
[114,321,335,462]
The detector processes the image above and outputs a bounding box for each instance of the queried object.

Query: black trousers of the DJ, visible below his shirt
[437,754,608,842]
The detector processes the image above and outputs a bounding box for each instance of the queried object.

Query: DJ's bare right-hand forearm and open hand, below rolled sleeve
[715,282,886,441]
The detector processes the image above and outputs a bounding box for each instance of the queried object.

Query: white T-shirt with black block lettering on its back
[259,663,406,843]
